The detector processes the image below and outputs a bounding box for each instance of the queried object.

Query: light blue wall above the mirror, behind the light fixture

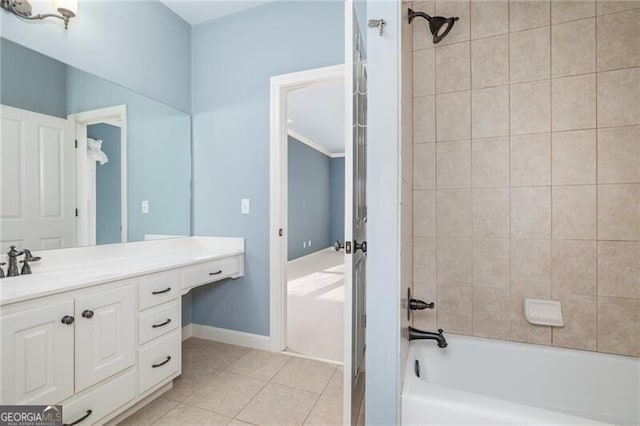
[0,1,191,111]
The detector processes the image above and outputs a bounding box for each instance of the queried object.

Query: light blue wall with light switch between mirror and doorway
[191,1,344,335]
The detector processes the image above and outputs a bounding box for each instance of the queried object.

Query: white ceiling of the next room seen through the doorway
[287,82,345,154]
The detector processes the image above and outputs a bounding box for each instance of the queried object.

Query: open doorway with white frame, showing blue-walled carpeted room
[270,65,345,363]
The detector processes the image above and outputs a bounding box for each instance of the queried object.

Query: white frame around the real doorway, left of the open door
[269,65,347,352]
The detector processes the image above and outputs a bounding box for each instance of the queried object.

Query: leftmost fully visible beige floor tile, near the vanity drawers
[185,372,265,417]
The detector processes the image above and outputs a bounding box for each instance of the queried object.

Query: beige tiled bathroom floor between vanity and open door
[120,338,350,426]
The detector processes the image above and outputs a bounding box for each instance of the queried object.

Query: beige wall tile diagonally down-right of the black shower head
[471,34,509,89]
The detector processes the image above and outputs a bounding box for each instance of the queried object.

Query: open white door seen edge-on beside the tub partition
[343,1,367,424]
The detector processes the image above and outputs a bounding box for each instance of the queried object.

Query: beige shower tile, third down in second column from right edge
[551,74,596,132]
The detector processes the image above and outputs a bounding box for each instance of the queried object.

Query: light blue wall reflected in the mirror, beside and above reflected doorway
[67,67,191,245]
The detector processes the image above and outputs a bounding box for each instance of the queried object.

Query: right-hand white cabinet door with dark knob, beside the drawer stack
[75,284,136,392]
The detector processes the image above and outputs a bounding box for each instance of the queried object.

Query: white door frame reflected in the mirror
[68,105,129,245]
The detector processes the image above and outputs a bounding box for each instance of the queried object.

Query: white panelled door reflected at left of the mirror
[0,105,76,253]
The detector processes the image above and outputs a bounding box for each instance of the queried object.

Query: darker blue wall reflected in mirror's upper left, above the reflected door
[0,38,67,118]
